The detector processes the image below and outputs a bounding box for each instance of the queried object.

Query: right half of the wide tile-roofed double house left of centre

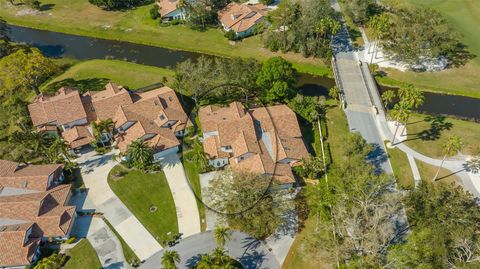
[113,87,189,160]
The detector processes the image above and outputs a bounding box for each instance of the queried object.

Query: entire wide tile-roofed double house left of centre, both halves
[29,83,189,159]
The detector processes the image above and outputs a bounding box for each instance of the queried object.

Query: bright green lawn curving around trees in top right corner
[381,0,480,98]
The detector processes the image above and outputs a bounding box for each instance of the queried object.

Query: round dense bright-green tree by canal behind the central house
[257,57,298,102]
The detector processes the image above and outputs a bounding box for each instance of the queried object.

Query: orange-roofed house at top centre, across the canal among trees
[218,2,268,37]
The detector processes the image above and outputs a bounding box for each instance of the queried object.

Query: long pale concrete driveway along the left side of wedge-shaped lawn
[77,152,162,260]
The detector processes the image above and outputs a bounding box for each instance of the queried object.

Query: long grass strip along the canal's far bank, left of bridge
[0,0,331,75]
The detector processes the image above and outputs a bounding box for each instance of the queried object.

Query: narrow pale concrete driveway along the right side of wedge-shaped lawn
[160,154,201,237]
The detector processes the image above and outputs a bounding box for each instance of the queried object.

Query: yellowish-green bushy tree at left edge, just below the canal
[0,48,59,95]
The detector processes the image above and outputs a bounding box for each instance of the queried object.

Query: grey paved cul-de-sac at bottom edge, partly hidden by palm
[140,231,280,269]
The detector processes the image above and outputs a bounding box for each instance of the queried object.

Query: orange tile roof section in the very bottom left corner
[0,222,40,267]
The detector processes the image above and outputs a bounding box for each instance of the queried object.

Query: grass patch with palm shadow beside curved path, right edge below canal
[406,114,480,158]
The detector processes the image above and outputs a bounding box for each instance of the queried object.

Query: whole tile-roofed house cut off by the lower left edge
[0,160,76,268]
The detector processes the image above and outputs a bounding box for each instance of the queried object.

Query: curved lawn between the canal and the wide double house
[42,60,174,92]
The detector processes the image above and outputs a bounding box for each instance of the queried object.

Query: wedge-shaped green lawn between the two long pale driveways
[108,166,178,245]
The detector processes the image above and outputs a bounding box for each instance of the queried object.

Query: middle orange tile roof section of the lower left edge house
[0,184,75,237]
